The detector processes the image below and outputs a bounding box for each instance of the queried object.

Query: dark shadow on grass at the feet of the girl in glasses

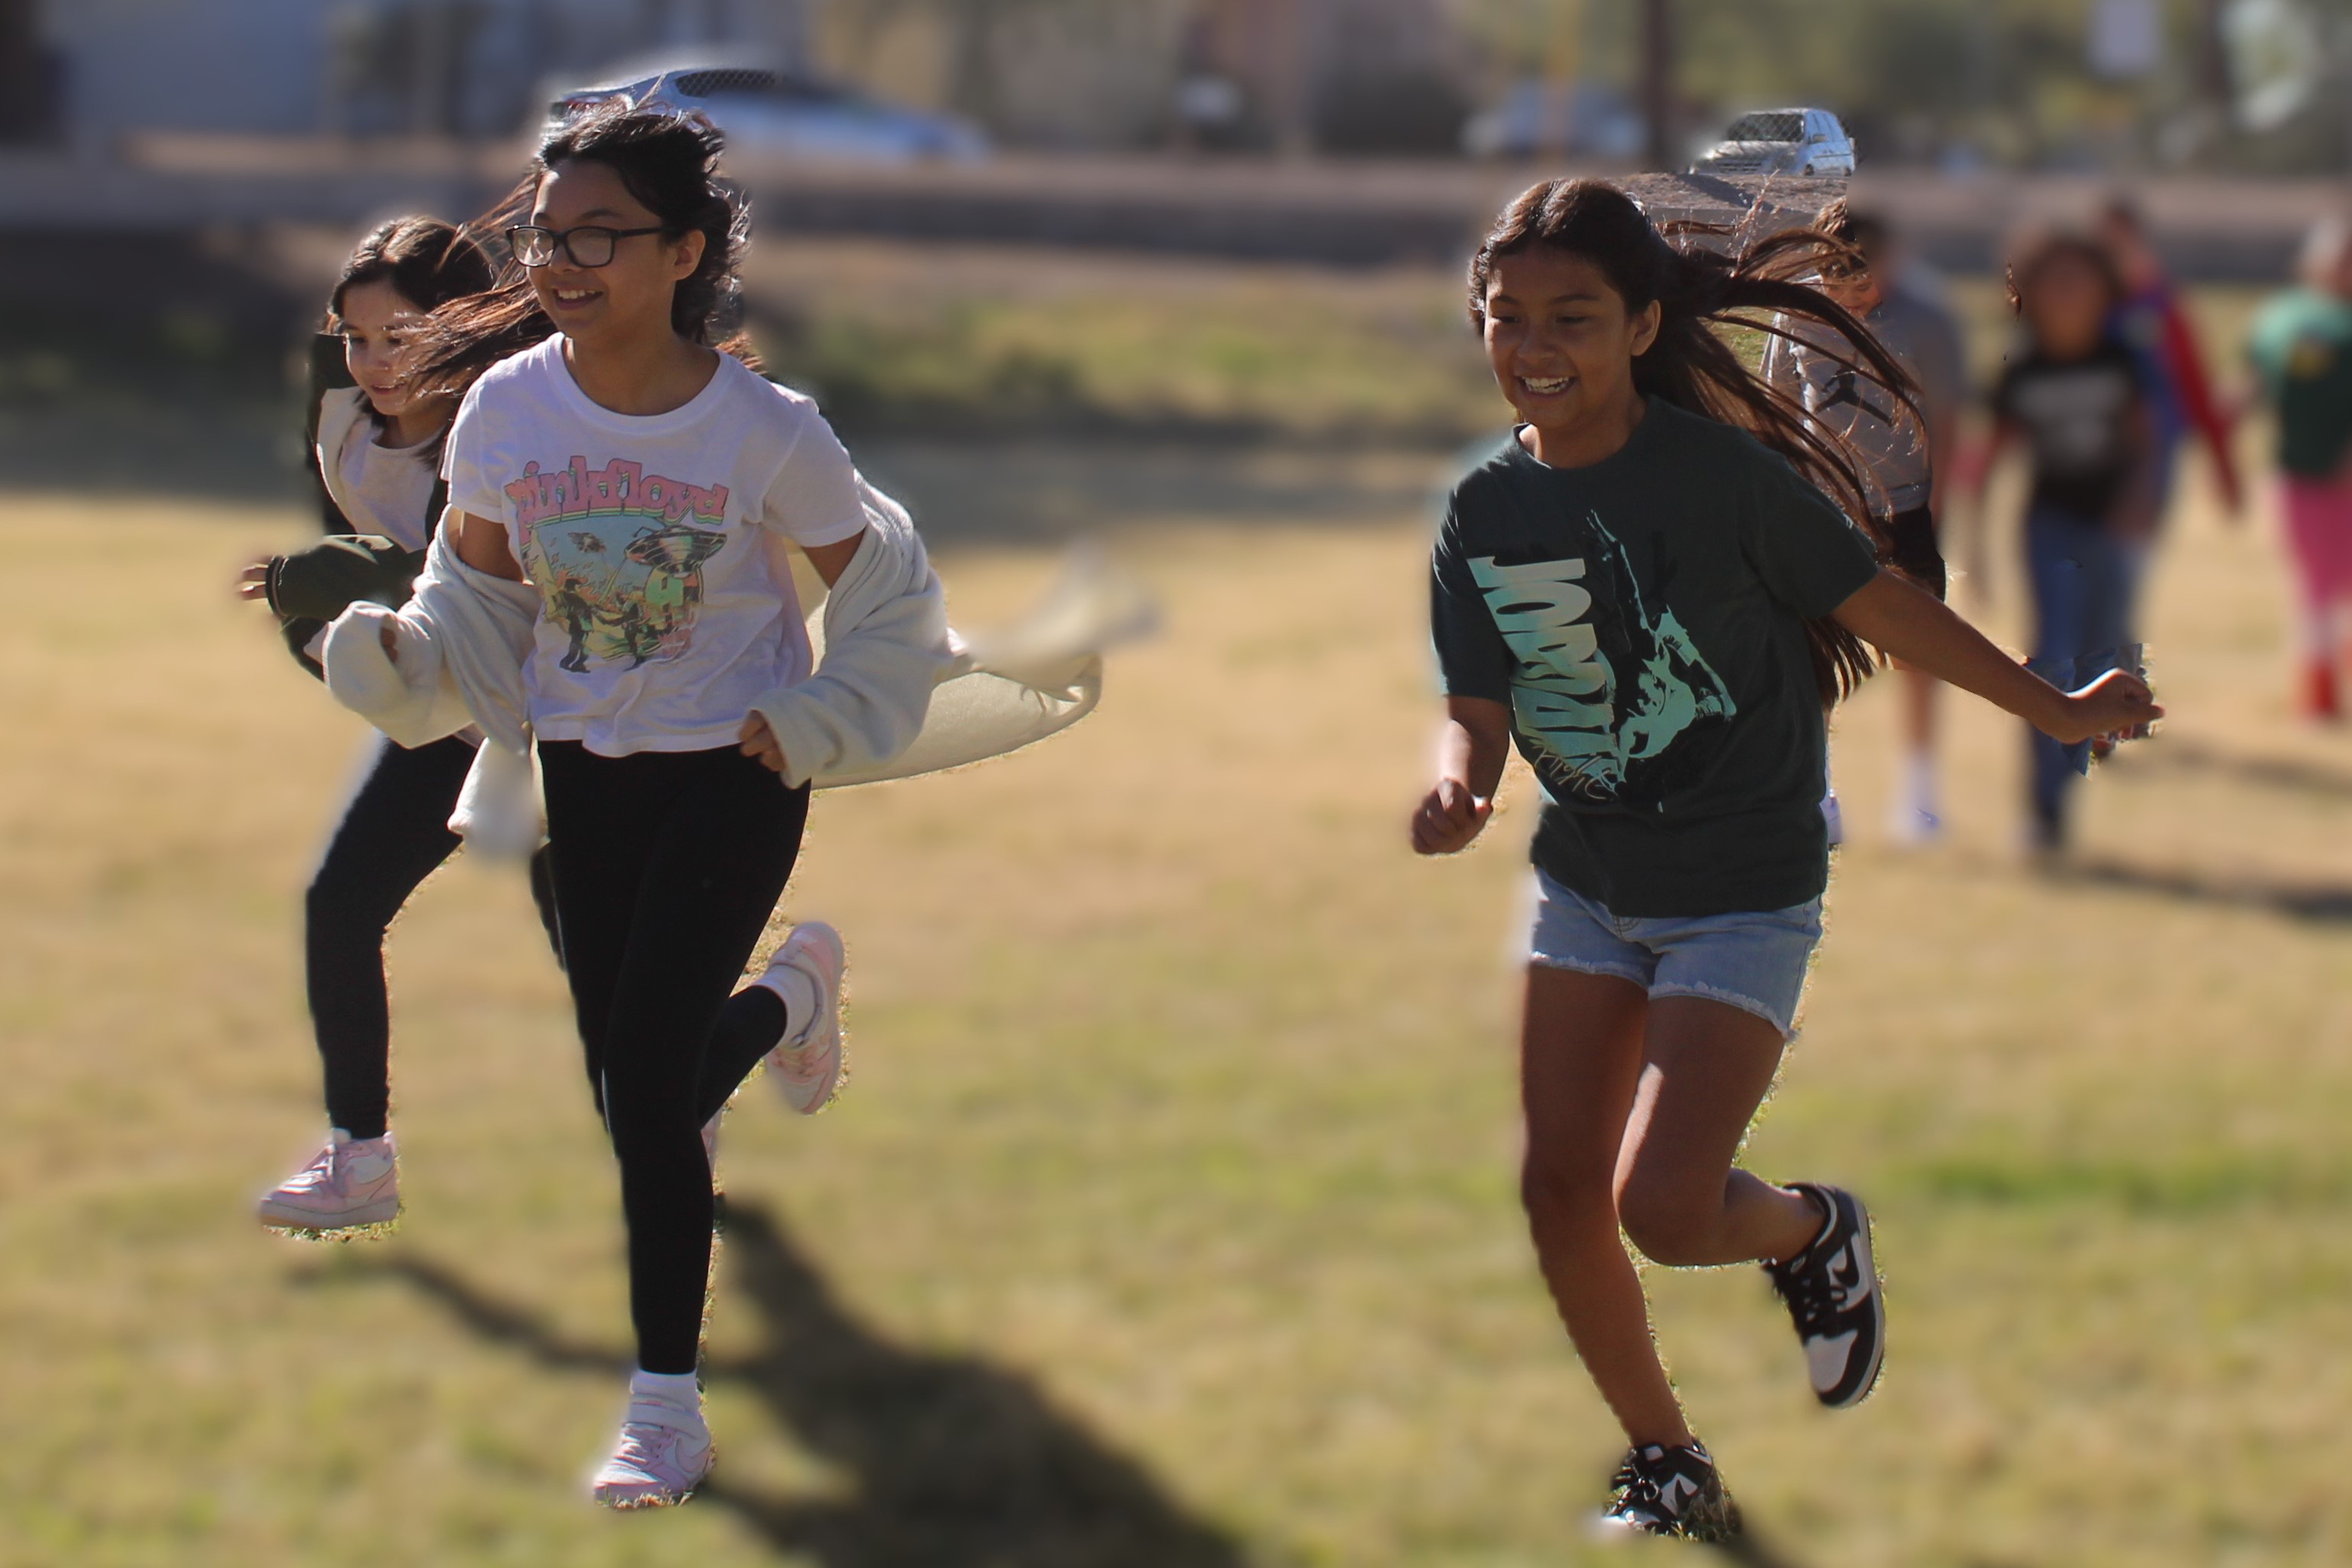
[352,1203,1244,1568]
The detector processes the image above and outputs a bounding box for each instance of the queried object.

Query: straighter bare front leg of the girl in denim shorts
[1520,964,1693,1448]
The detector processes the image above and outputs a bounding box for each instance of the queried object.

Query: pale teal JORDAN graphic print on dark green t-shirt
[1470,512,1738,806]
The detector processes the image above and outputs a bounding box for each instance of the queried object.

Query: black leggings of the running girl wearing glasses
[538,740,809,1373]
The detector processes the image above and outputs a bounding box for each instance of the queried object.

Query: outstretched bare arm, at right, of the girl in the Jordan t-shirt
[1832,569,2164,745]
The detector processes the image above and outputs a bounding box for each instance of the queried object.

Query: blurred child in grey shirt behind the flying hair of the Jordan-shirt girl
[1764,197,1967,844]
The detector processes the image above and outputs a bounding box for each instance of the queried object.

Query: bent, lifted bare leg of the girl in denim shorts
[1616,997,1828,1267]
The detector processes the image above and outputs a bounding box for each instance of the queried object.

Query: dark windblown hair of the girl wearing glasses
[412,99,750,395]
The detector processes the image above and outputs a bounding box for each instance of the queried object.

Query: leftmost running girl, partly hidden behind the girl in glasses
[237,217,553,1234]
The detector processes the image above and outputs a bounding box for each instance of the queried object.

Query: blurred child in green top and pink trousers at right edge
[2248,219,2352,719]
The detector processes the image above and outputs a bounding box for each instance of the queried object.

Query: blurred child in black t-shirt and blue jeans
[1987,235,2162,853]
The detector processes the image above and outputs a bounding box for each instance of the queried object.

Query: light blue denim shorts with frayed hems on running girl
[1527,872,1821,1039]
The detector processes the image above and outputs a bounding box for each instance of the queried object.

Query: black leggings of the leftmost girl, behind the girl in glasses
[303,738,555,1138]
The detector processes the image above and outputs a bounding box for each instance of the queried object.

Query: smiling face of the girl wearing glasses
[531,160,703,343]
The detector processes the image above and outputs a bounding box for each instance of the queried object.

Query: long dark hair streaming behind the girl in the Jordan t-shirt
[1470,179,1917,703]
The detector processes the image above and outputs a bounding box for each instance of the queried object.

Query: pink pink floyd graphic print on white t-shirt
[506,456,726,675]
